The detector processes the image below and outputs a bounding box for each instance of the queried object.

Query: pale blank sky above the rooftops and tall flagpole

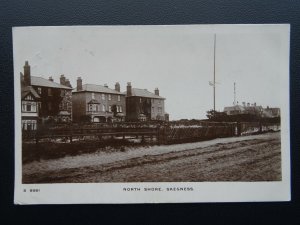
[13,25,288,120]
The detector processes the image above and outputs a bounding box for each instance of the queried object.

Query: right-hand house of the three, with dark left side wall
[125,82,168,121]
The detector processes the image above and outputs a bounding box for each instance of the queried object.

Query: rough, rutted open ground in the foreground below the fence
[23,132,281,183]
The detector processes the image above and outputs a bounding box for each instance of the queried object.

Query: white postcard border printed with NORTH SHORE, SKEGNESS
[13,24,291,204]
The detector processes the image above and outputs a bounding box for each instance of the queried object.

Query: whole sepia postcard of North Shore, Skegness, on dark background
[13,24,290,203]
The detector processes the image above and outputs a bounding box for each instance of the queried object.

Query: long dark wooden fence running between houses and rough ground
[22,122,280,144]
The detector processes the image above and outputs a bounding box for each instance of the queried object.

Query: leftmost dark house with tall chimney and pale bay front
[21,61,72,129]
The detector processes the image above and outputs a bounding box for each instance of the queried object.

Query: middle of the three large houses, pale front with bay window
[72,77,126,122]
